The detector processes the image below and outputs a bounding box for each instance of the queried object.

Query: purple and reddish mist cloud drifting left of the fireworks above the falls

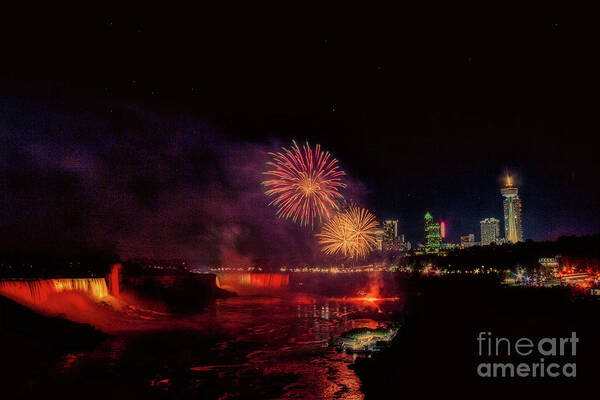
[0,98,364,266]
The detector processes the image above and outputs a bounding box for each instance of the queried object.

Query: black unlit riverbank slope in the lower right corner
[353,278,600,399]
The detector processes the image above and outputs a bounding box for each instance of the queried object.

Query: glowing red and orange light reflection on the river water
[194,297,386,399]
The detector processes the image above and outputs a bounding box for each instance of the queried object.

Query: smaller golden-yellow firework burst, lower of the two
[317,205,379,259]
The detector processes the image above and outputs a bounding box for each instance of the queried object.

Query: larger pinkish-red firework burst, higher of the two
[262,141,346,226]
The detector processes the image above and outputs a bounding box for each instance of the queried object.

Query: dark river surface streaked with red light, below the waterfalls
[57,295,396,399]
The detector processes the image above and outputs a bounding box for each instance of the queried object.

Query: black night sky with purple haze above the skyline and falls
[0,10,600,263]
